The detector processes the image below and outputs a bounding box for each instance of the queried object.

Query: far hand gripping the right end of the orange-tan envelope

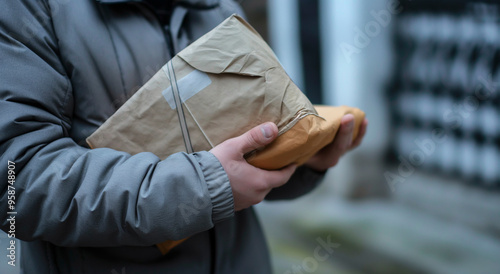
[306,114,368,172]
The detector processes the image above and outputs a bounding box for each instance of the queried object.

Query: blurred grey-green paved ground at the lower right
[257,191,500,274]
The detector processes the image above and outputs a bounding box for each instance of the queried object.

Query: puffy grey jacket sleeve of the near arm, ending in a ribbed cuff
[0,1,234,246]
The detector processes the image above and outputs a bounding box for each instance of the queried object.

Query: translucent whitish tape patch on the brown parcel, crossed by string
[161,70,212,109]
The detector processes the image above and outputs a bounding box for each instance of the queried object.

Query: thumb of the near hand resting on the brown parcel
[234,122,278,154]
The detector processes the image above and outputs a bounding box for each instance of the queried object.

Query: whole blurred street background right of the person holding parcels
[241,0,500,274]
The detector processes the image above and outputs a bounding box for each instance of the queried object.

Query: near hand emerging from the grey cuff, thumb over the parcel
[210,123,296,211]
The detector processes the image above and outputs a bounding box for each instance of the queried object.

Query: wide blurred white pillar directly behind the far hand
[320,0,394,196]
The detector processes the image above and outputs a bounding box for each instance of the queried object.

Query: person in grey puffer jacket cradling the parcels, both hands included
[0,0,366,273]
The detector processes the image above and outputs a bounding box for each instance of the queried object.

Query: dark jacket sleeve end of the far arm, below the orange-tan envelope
[266,166,326,201]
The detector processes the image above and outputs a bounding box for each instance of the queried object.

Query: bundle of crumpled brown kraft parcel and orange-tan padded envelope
[87,15,364,254]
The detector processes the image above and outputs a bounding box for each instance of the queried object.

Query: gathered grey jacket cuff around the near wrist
[194,151,234,223]
